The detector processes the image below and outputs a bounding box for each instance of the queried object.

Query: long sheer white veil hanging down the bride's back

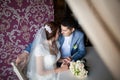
[27,27,46,78]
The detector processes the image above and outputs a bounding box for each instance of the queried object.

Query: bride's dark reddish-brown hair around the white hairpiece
[45,21,58,40]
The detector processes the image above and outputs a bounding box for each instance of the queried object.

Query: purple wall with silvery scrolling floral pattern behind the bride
[0,0,54,80]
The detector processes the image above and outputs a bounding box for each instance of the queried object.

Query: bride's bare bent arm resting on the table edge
[36,56,68,75]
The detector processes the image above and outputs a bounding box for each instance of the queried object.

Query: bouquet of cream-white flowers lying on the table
[69,60,88,79]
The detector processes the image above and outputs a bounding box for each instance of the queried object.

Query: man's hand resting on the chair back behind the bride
[15,52,29,69]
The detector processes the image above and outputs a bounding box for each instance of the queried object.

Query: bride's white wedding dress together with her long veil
[27,28,60,80]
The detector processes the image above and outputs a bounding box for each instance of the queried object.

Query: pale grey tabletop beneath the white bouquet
[59,47,114,80]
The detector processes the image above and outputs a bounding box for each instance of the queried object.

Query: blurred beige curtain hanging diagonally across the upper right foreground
[66,0,120,80]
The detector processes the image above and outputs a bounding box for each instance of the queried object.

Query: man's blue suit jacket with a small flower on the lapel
[25,30,86,61]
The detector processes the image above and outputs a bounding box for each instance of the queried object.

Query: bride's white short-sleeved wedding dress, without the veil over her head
[27,41,60,80]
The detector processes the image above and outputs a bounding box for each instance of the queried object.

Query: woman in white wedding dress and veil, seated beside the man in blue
[27,22,68,80]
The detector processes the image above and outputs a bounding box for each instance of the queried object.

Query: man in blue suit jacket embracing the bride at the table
[16,17,86,67]
